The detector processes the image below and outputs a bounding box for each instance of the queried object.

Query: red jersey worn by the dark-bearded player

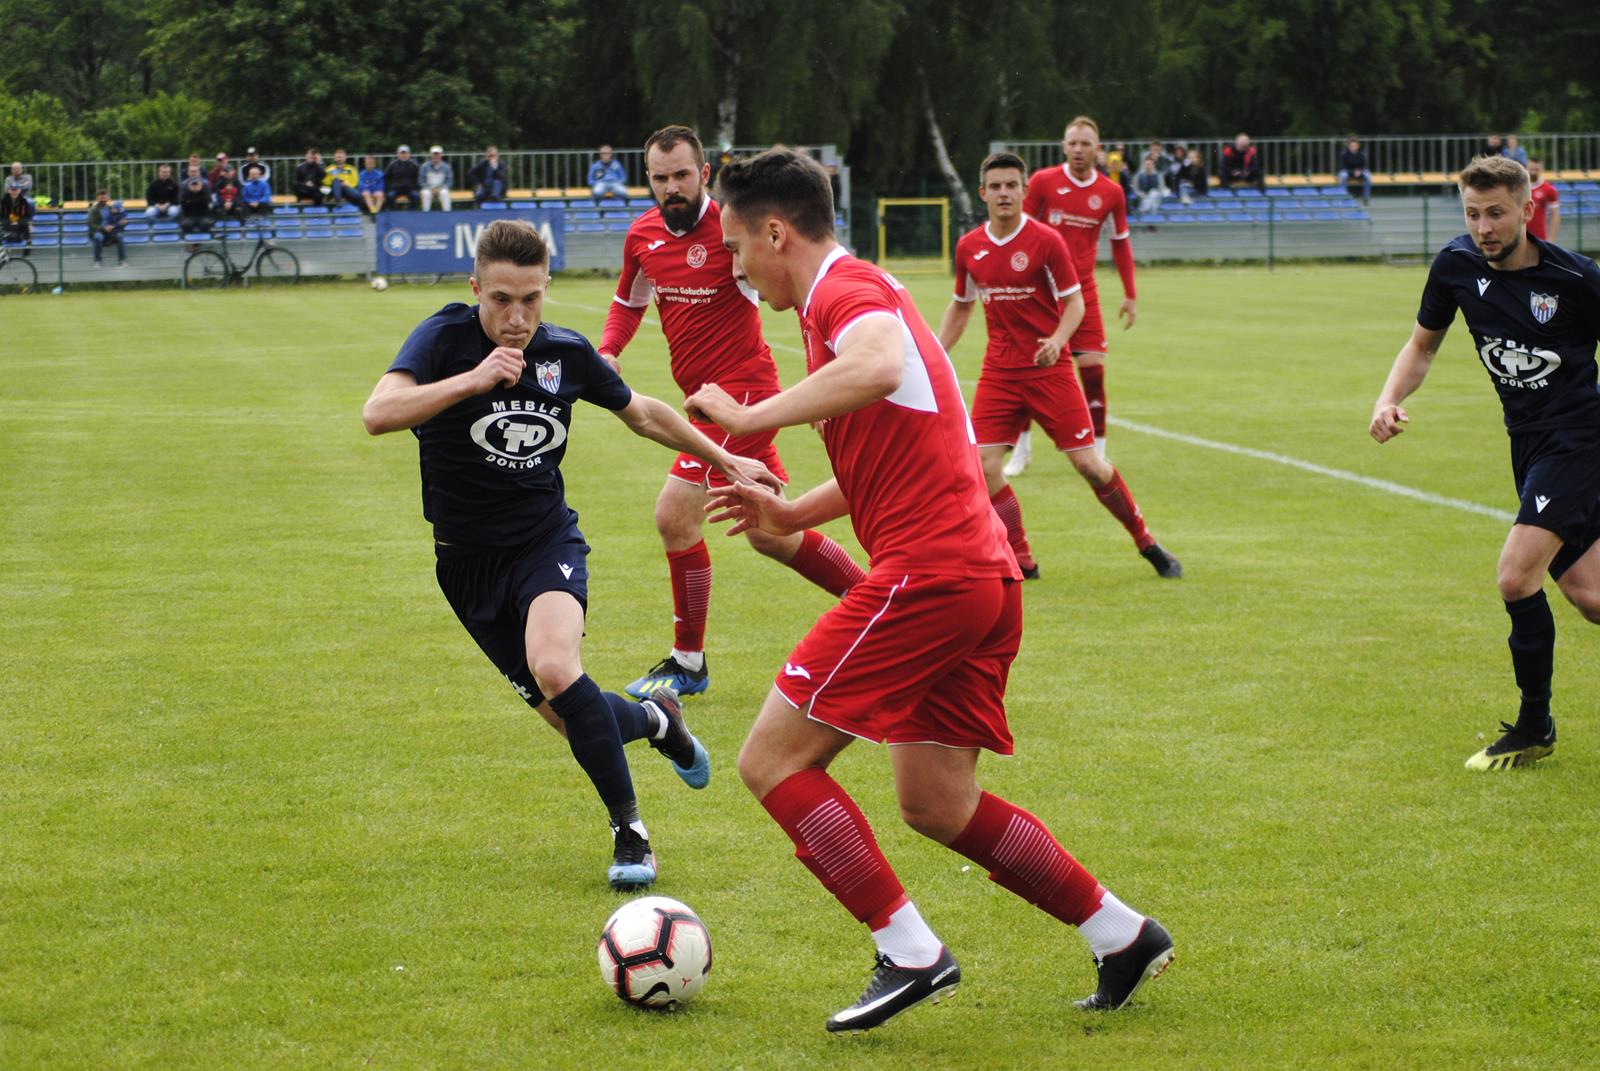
[613,197,779,395]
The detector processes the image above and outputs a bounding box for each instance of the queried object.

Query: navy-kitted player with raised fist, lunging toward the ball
[362,221,778,888]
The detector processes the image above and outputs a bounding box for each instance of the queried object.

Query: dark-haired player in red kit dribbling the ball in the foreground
[686,149,1173,1031]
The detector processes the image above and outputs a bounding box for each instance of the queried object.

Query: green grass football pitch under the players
[0,267,1600,1069]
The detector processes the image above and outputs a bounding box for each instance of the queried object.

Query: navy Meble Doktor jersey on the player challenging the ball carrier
[389,303,634,546]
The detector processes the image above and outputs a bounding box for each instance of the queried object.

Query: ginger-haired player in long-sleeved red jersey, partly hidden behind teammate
[1022,115,1136,455]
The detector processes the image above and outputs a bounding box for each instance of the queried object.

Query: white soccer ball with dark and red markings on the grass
[598,897,710,1009]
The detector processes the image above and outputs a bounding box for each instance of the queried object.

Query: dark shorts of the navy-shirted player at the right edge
[1510,429,1600,580]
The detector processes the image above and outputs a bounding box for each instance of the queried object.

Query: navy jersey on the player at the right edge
[1416,234,1600,434]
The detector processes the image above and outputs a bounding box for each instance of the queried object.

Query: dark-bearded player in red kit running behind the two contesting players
[600,126,866,700]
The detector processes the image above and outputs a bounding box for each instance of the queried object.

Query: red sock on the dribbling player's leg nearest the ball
[762,767,915,929]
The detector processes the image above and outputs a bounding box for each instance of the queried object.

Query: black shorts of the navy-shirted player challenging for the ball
[434,528,589,706]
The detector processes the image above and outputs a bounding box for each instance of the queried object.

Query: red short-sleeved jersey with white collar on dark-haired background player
[955,216,1083,373]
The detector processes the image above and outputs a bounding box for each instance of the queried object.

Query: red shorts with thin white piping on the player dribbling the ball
[773,573,1022,756]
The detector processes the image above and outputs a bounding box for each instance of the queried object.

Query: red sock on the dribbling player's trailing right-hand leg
[950,792,1104,925]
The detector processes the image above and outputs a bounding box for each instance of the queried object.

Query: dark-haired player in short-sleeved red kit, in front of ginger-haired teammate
[939,152,1184,580]
